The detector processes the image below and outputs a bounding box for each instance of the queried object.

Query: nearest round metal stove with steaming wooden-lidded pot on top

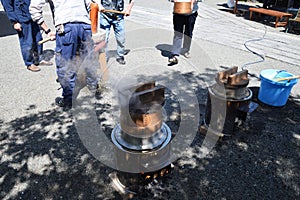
[111,82,172,174]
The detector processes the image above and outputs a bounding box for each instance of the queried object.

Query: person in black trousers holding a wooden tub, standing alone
[169,0,198,66]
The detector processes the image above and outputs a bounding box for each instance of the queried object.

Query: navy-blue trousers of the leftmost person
[17,21,43,67]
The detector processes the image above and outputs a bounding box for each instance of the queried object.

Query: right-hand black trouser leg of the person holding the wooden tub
[182,12,198,54]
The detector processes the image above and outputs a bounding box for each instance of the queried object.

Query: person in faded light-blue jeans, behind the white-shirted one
[96,0,134,65]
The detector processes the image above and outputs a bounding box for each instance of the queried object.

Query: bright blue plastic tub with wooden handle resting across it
[258,69,298,106]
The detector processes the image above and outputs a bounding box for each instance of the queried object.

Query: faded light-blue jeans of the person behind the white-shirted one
[100,13,125,58]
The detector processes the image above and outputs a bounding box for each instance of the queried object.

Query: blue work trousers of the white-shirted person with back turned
[55,23,98,101]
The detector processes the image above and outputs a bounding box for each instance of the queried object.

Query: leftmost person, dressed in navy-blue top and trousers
[1,0,52,72]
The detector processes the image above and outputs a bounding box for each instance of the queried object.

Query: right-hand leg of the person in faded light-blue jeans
[113,15,125,59]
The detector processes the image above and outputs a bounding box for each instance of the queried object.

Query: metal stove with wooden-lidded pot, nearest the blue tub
[200,67,257,136]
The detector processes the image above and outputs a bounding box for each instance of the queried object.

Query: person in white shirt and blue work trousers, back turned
[30,0,98,110]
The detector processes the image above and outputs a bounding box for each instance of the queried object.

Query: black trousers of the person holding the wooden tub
[172,12,198,55]
